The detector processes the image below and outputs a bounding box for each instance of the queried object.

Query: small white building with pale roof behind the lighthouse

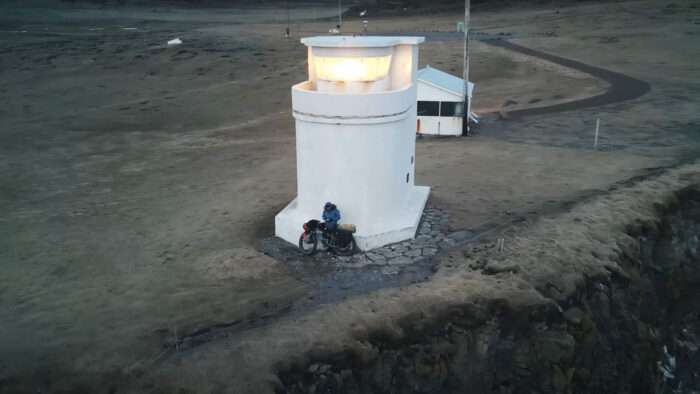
[416,66,477,135]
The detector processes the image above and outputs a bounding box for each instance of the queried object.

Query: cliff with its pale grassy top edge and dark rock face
[108,164,700,393]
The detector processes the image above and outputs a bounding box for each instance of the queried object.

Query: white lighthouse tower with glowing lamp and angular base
[275,36,430,250]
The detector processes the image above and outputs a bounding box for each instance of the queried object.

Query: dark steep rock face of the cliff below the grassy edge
[278,188,700,393]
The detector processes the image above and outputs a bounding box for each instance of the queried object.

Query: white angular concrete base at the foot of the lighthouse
[275,186,430,250]
